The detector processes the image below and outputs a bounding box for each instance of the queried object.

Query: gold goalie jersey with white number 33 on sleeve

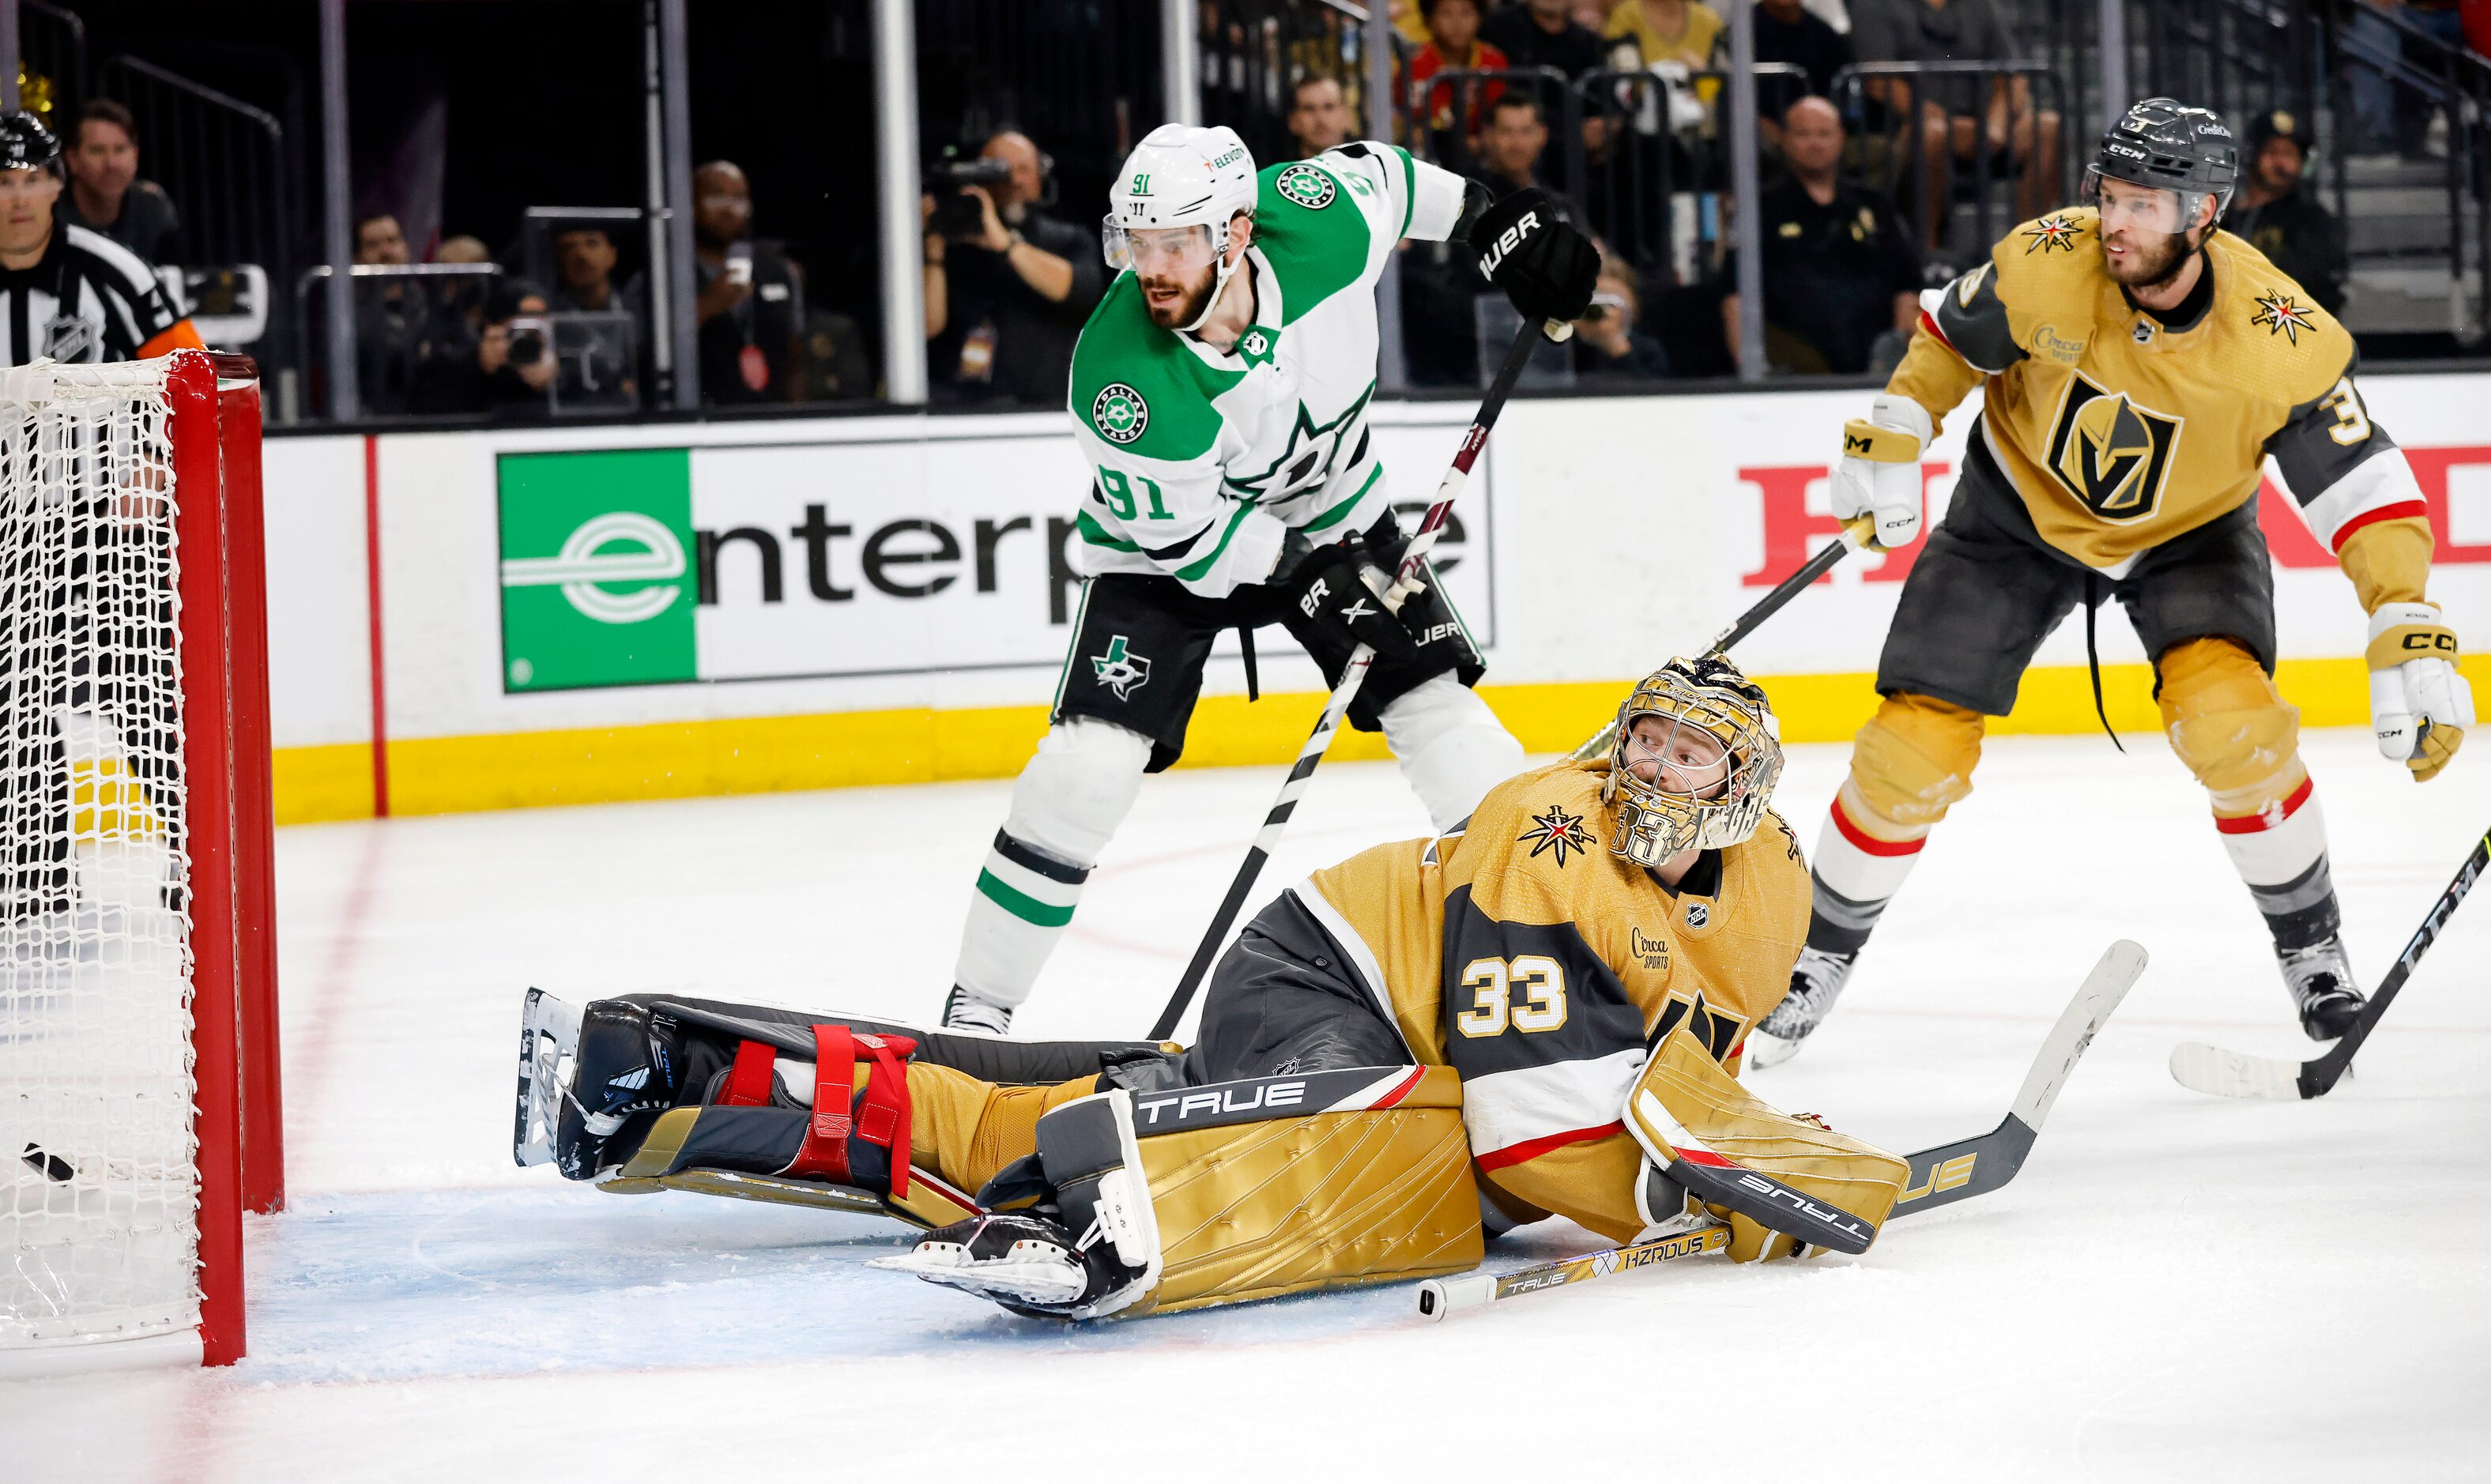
[1295,759,1808,1240]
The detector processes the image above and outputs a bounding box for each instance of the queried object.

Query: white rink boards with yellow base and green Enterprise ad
[247,374,2491,822]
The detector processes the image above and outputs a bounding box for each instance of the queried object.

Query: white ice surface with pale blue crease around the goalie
[0,732,2491,1484]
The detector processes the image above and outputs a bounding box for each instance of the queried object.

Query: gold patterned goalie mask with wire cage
[1602,655,1781,867]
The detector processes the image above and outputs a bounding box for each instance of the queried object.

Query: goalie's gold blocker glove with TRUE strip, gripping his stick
[1626,1031,1911,1263]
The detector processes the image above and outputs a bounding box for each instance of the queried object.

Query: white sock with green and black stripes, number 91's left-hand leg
[952,717,1151,1006]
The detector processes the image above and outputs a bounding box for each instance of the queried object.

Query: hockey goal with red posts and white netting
[0,351,281,1374]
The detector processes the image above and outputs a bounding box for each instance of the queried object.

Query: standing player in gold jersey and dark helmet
[1756,97,2474,1066]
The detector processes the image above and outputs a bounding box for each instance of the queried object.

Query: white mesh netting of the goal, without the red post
[0,361,199,1350]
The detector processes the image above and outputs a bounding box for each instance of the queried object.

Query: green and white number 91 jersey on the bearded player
[1071,142,1464,597]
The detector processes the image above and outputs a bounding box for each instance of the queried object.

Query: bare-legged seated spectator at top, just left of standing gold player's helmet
[1851,0,2060,251]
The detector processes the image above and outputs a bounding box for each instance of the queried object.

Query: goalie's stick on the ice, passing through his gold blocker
[1417,946,2142,1320]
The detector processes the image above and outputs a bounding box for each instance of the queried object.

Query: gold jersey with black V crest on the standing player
[1886,209,2431,608]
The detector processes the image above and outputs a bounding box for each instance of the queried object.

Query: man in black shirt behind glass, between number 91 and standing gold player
[1721,97,1920,376]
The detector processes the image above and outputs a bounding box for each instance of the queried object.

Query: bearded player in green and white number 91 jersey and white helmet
[944,125,1596,1034]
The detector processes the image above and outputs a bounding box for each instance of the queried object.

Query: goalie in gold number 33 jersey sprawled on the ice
[521,660,1905,1317]
